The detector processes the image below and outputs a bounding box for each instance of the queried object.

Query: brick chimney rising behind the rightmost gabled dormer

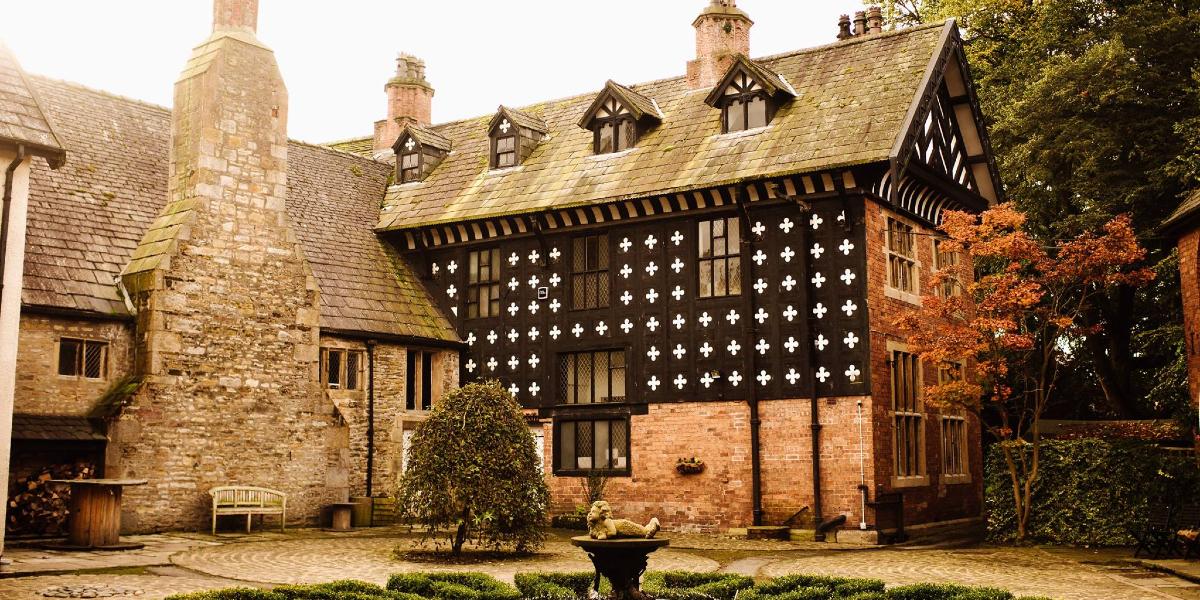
[688,0,754,90]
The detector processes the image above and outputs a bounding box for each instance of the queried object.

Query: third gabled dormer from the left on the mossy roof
[580,79,662,154]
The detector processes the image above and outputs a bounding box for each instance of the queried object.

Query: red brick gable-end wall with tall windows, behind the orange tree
[865,200,983,524]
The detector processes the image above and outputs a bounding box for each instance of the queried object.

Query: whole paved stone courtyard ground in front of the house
[0,529,1200,600]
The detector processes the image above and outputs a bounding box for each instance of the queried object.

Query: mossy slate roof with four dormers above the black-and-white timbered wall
[376,22,955,230]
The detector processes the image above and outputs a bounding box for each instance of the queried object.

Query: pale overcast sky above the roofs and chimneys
[0,0,863,142]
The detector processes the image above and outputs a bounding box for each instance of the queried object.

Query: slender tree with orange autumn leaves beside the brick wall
[896,204,1154,540]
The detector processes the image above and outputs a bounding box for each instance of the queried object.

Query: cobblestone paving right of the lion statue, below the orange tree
[760,548,1200,600]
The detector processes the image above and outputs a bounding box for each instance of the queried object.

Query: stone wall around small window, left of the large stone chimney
[14,312,133,415]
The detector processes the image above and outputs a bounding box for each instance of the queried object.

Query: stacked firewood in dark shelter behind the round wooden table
[8,461,96,535]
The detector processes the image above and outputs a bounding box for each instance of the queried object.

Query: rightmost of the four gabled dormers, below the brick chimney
[704,54,796,133]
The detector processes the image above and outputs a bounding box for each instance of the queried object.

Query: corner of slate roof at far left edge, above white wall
[0,42,66,168]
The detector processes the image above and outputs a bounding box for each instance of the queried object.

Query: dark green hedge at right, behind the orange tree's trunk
[984,439,1200,546]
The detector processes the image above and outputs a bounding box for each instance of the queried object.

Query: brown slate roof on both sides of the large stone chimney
[22,78,457,340]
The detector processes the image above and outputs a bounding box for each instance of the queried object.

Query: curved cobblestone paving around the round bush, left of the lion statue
[172,538,720,583]
